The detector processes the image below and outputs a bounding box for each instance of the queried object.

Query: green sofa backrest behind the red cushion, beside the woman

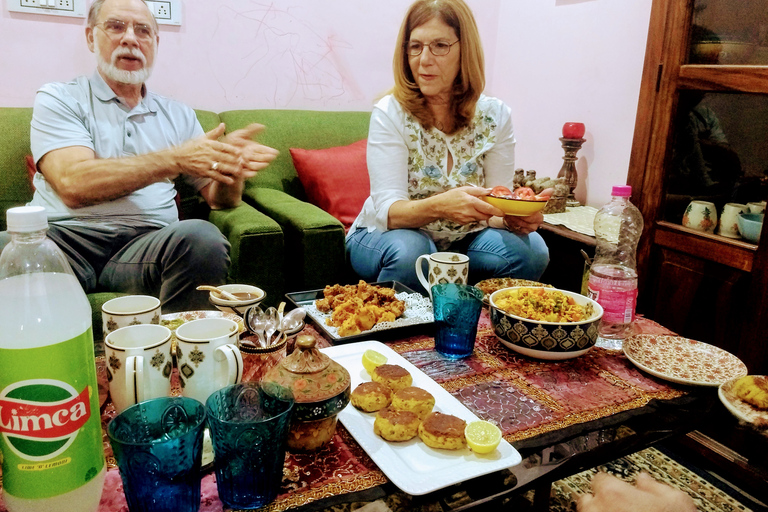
[219,110,371,199]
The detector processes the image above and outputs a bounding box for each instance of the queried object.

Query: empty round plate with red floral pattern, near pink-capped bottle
[623,334,747,386]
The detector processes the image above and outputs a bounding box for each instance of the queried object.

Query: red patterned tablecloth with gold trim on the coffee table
[0,310,684,512]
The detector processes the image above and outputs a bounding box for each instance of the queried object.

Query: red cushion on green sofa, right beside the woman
[291,139,371,230]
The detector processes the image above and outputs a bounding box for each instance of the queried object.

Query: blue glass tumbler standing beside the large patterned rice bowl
[432,283,483,359]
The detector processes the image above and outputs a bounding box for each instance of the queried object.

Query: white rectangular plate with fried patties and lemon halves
[321,341,522,495]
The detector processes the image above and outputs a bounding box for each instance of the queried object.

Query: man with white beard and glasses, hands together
[16,0,277,313]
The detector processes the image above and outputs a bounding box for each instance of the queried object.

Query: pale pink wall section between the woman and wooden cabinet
[490,0,652,207]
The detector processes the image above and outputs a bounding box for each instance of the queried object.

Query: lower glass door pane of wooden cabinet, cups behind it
[663,90,768,239]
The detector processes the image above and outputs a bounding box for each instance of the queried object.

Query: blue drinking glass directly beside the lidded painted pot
[205,382,294,509]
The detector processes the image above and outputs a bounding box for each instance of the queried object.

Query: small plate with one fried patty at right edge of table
[717,375,768,429]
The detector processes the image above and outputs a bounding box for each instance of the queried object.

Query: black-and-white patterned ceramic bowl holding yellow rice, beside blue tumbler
[490,286,603,360]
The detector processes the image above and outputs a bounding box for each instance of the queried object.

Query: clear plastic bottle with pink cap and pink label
[588,185,643,342]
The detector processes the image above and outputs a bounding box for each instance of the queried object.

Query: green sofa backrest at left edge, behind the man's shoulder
[0,107,32,231]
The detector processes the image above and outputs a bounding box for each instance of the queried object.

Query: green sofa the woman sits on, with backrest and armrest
[219,110,370,292]
